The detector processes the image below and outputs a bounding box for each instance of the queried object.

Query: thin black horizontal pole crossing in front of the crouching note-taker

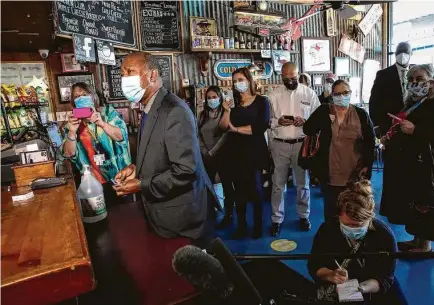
[233,251,434,261]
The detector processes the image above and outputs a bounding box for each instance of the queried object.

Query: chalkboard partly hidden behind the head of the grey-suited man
[106,55,173,100]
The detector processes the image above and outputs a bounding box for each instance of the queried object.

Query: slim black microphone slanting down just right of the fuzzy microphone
[211,238,262,305]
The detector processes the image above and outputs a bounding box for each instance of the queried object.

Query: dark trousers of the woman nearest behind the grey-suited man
[203,156,235,216]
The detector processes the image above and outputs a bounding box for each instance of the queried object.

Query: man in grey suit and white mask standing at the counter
[114,52,221,244]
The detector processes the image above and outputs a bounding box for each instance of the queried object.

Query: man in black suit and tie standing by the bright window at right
[369,42,412,137]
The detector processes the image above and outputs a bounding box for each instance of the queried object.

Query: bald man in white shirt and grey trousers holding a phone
[269,62,320,236]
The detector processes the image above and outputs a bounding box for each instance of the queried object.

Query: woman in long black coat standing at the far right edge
[380,65,434,252]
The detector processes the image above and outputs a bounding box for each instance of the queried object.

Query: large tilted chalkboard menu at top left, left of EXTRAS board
[54,0,137,48]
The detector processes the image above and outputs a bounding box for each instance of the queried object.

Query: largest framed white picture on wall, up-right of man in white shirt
[301,37,332,73]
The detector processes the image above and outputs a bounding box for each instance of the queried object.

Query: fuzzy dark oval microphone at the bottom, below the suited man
[172,245,234,300]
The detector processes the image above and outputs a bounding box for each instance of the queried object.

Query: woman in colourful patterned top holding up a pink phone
[60,83,131,189]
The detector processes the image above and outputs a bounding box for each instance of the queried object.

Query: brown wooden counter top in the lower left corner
[1,180,95,305]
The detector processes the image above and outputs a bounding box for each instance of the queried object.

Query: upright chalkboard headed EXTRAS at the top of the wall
[139,1,182,51]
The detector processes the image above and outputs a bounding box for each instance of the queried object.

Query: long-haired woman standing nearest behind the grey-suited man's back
[198,86,235,228]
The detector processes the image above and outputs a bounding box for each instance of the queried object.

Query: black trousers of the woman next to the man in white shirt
[232,168,263,229]
